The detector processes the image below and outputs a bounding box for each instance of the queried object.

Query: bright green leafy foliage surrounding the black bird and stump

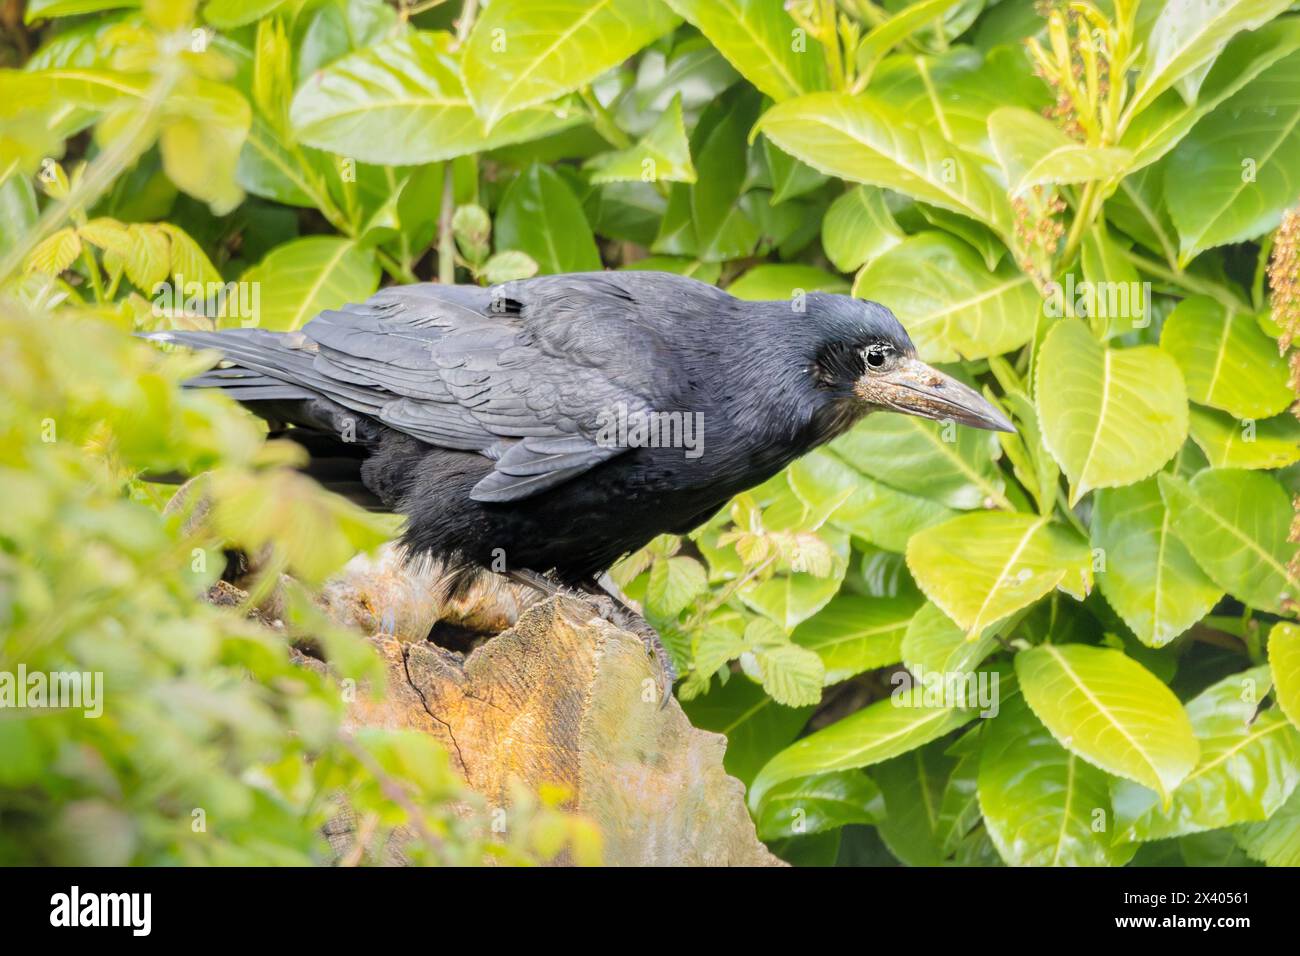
[0,0,1300,865]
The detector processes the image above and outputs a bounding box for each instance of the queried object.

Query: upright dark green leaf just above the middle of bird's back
[497,164,601,276]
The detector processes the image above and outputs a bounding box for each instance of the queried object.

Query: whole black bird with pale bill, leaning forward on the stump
[151,272,1011,685]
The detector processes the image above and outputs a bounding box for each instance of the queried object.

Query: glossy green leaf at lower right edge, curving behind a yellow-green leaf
[1113,667,1300,840]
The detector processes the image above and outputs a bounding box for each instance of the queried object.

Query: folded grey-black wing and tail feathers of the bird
[166,280,670,502]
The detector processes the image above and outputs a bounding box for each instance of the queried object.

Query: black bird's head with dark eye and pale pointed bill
[806,293,1015,432]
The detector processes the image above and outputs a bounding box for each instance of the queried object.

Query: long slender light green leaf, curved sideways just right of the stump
[749,700,975,809]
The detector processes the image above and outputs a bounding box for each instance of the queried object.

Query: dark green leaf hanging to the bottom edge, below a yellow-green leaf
[979,695,1136,866]
